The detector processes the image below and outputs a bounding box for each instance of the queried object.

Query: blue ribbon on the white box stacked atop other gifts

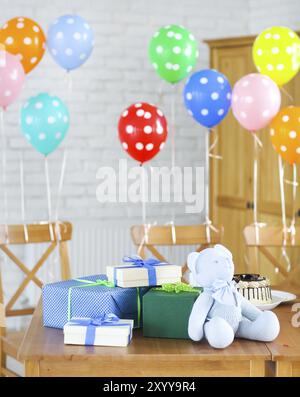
[114,255,167,286]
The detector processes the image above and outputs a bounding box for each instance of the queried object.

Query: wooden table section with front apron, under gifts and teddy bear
[19,305,271,377]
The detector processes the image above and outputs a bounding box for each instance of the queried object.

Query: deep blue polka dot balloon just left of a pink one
[183,69,231,128]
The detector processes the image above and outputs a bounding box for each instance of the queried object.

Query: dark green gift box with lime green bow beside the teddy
[143,283,202,339]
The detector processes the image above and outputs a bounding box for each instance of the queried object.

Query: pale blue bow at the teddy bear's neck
[204,279,242,306]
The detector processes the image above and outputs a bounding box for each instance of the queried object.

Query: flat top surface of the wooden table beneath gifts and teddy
[18,303,271,361]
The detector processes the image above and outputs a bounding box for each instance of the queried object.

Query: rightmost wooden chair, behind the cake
[244,225,300,291]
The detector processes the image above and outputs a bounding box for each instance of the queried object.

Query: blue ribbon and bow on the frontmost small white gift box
[70,313,131,346]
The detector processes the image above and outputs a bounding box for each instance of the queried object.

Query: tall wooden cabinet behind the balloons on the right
[207,37,300,283]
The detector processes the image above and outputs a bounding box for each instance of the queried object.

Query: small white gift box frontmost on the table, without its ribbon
[64,318,133,347]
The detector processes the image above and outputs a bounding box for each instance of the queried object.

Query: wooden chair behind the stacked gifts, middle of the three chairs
[131,225,223,274]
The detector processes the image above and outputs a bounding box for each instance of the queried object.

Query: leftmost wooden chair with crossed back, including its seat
[0,222,72,376]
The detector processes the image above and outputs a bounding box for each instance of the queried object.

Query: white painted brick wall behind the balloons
[0,0,248,227]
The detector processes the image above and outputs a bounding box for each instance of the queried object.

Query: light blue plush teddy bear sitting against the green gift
[187,244,280,349]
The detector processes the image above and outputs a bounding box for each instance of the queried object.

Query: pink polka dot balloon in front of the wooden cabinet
[232,73,281,131]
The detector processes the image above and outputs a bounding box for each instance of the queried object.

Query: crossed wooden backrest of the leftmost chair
[0,222,72,317]
